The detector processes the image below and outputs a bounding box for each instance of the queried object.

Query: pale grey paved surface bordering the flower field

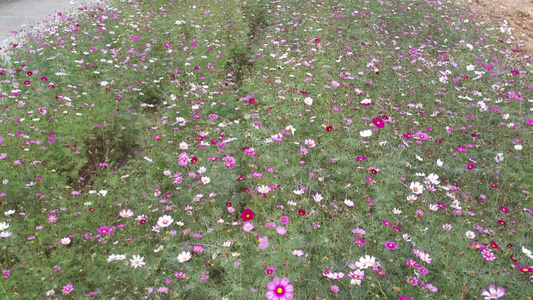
[0,0,87,53]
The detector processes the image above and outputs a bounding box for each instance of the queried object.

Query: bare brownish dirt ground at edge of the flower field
[460,0,533,56]
